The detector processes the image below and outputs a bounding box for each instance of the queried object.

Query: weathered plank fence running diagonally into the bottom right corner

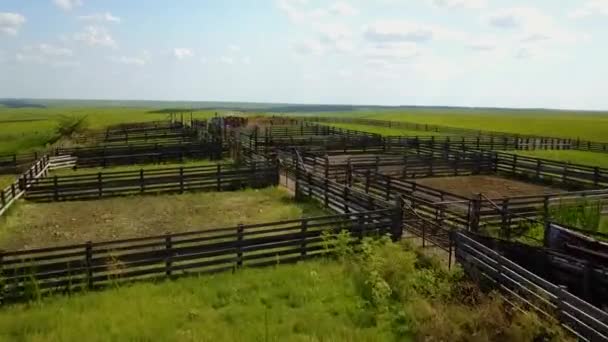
[453,232,608,341]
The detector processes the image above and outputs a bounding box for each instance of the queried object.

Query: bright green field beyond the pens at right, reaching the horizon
[322,108,608,142]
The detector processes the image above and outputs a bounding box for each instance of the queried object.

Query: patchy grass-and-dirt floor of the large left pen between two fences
[0,188,323,250]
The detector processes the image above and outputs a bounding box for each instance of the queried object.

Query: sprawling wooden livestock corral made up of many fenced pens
[1,118,608,337]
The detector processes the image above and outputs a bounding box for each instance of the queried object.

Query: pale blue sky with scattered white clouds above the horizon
[0,0,608,109]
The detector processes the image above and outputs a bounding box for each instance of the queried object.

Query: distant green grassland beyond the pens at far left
[0,107,215,154]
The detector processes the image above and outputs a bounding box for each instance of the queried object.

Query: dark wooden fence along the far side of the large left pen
[25,162,278,202]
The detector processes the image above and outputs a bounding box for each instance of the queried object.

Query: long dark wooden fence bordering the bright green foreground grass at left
[0,209,396,303]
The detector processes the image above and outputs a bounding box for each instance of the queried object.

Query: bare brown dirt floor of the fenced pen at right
[414,176,564,199]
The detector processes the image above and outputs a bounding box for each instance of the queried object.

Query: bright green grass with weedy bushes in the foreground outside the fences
[0,239,568,342]
